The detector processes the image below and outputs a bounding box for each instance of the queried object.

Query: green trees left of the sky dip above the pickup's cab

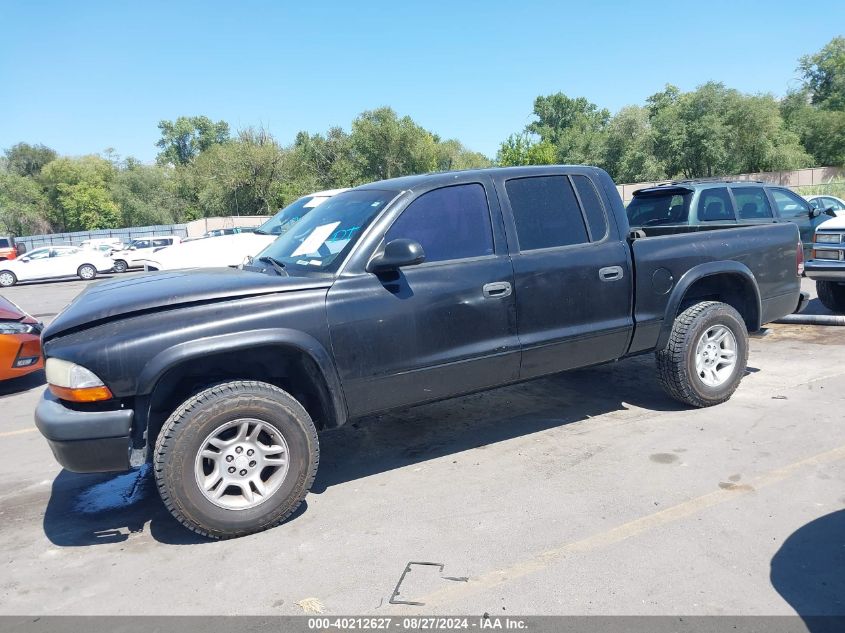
[0,107,492,235]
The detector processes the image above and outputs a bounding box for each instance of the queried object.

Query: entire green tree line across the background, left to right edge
[0,37,845,235]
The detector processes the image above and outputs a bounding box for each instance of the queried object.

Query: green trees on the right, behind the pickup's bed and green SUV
[497,37,845,182]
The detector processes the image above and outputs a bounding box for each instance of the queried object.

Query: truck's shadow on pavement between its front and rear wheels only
[311,355,687,494]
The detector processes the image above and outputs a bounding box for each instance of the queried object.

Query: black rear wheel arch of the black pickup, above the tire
[657,262,762,349]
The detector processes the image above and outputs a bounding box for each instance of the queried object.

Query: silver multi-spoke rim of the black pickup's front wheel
[194,418,288,510]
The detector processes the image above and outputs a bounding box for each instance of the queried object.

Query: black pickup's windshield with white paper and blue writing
[258,190,396,271]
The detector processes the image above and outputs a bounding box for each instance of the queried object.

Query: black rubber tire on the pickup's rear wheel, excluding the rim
[655,301,748,407]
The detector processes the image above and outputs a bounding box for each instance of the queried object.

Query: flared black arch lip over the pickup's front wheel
[137,328,347,426]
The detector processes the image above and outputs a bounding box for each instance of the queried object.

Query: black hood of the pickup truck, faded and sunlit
[44,268,332,340]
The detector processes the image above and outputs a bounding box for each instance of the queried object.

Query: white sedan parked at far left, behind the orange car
[0,246,114,288]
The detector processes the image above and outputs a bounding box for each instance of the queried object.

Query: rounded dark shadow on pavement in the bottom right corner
[770,509,845,632]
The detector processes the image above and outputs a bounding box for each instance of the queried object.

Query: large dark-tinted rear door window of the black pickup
[505,176,590,251]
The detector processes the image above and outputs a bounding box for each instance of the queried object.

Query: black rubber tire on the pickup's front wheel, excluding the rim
[153,381,320,539]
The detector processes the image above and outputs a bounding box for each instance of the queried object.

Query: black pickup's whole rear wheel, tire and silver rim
[656,301,748,407]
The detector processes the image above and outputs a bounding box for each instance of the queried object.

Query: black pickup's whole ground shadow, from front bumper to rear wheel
[43,356,685,547]
